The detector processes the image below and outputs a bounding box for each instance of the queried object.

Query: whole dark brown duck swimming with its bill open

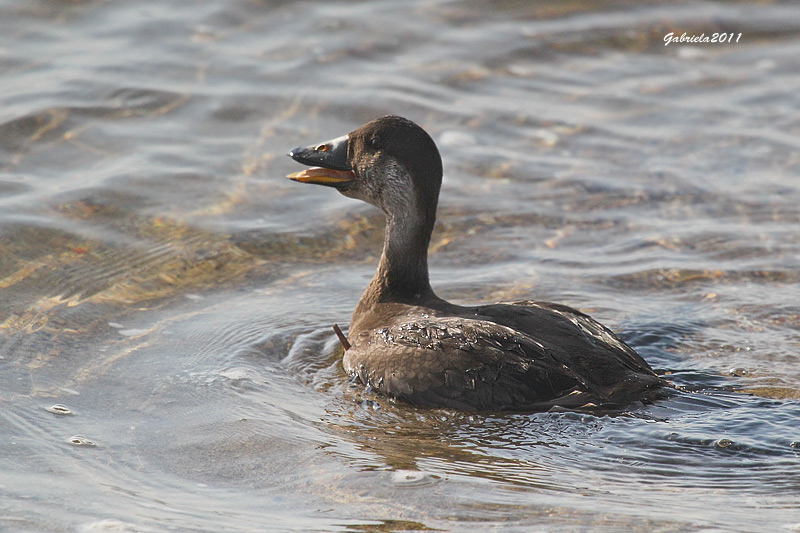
[288,116,664,412]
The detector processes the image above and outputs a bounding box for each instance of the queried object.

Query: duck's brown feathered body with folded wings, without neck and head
[344,301,662,411]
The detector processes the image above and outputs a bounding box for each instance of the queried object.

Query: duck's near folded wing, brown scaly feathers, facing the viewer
[344,317,606,411]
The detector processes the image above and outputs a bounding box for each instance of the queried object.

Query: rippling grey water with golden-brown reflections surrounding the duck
[0,0,800,532]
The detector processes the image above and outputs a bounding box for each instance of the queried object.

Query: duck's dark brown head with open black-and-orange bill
[288,116,442,218]
